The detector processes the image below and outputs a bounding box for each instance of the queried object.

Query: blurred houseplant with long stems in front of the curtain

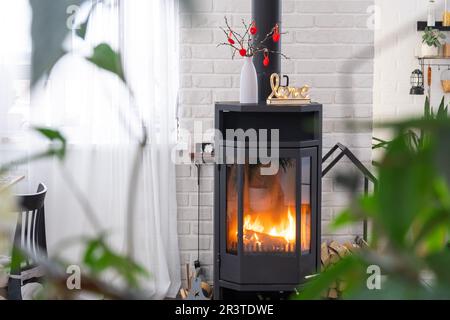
[0,0,150,299]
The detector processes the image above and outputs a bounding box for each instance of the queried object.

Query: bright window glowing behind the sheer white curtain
[0,0,179,148]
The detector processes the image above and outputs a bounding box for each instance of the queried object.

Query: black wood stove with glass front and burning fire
[214,103,322,299]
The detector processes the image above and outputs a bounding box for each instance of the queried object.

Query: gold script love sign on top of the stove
[267,73,311,105]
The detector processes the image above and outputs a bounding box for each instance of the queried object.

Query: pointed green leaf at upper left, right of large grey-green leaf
[87,43,126,83]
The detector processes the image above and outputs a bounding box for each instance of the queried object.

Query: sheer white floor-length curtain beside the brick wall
[23,0,181,299]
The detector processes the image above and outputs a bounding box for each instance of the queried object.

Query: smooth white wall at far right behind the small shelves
[373,0,450,137]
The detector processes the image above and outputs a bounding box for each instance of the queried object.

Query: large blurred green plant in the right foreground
[294,101,450,299]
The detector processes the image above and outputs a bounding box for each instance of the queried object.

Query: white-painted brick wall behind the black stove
[177,0,374,279]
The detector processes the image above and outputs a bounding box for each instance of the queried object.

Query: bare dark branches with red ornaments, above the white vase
[217,17,289,67]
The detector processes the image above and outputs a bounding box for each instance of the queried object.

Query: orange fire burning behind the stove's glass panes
[227,160,311,254]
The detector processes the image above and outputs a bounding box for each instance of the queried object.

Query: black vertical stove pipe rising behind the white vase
[252,0,282,104]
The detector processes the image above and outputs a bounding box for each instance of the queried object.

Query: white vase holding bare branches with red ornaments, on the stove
[218,17,286,103]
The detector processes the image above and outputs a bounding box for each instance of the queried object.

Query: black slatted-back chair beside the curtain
[8,183,47,300]
